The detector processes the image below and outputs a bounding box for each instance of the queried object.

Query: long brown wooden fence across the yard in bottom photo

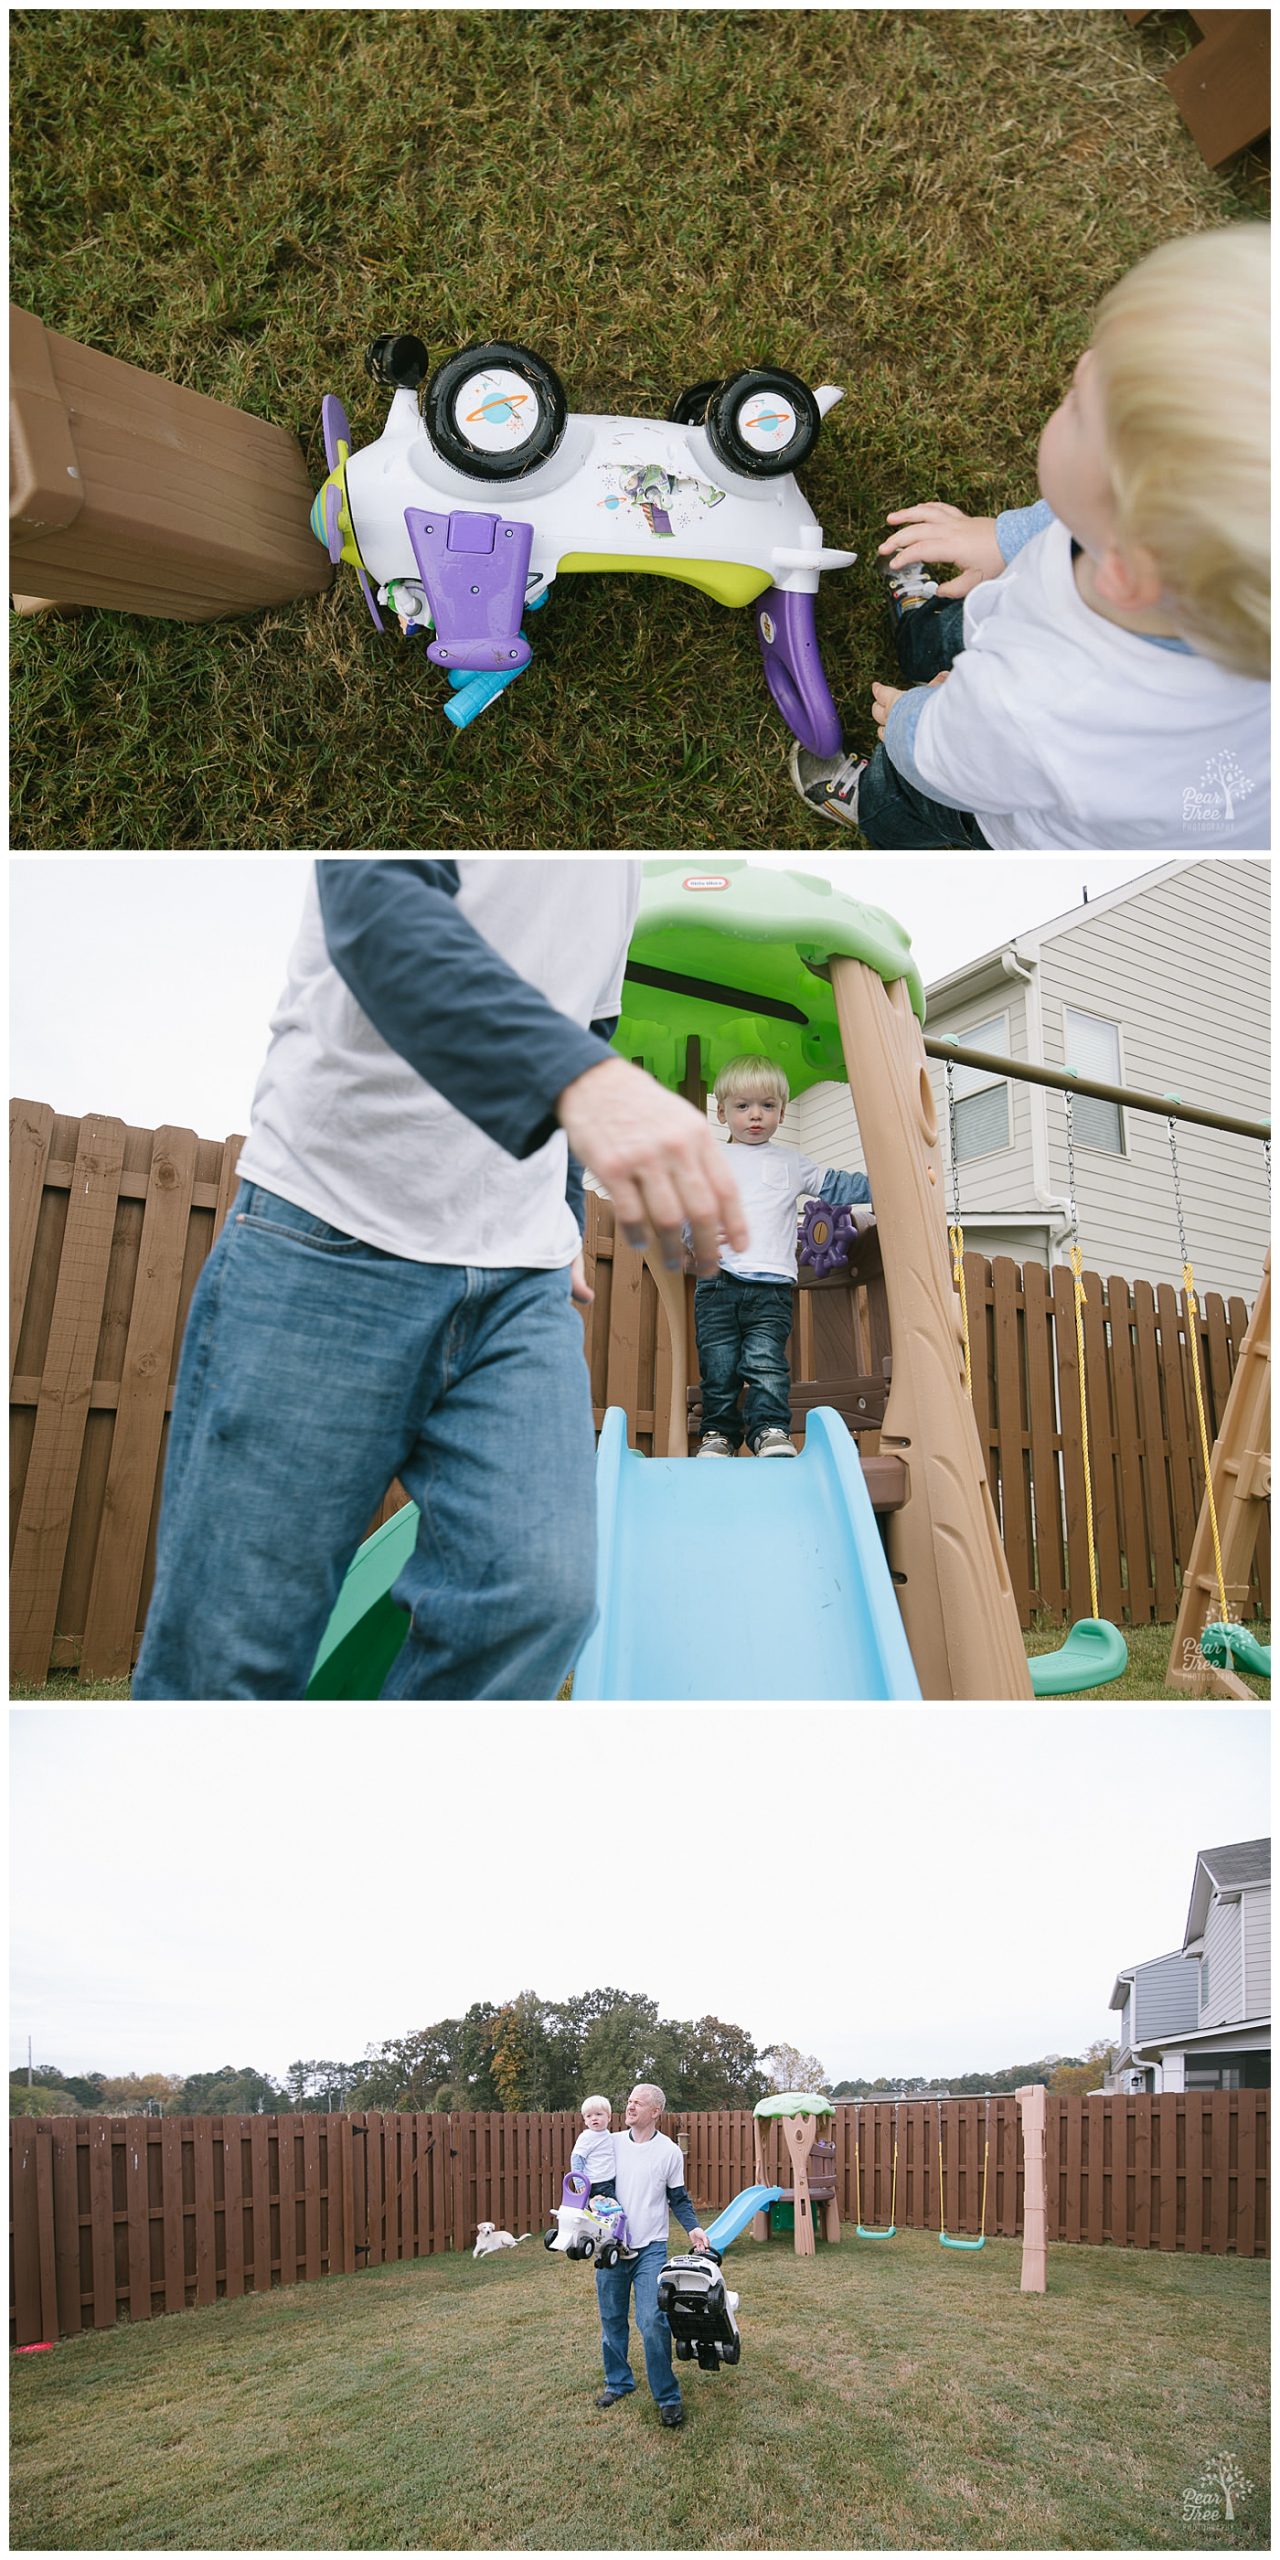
[10,2089,1270,2345]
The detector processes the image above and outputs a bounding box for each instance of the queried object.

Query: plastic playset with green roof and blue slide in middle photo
[307,858,1270,1705]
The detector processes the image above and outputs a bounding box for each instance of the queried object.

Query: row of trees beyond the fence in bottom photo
[10,1987,1111,2115]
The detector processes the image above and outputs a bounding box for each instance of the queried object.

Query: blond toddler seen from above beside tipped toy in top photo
[791,223,1270,852]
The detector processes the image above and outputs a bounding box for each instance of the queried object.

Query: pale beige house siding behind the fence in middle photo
[786,858,1270,1303]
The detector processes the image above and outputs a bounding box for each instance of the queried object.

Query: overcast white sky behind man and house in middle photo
[10,852,1172,1139]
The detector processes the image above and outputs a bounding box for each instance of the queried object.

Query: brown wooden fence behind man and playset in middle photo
[10,1101,1270,1682]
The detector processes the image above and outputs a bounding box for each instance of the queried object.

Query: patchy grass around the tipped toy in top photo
[10,8,1267,850]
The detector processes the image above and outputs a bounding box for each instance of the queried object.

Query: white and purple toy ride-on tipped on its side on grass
[310,335,855,755]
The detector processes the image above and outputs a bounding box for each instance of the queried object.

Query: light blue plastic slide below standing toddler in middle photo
[573,1405,919,1705]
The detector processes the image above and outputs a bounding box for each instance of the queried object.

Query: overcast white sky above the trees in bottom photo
[10,1708,1270,2081]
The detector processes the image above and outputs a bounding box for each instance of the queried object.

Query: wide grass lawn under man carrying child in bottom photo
[10,2232,1270,2550]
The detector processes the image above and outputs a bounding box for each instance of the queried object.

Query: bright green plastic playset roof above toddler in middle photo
[614,860,924,1093]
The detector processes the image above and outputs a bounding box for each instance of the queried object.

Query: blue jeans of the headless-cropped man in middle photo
[133,1183,596,1700]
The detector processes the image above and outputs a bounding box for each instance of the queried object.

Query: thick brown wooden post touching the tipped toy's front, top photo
[10,307,333,622]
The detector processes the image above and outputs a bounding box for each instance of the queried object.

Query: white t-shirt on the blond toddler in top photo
[911,522,1270,855]
